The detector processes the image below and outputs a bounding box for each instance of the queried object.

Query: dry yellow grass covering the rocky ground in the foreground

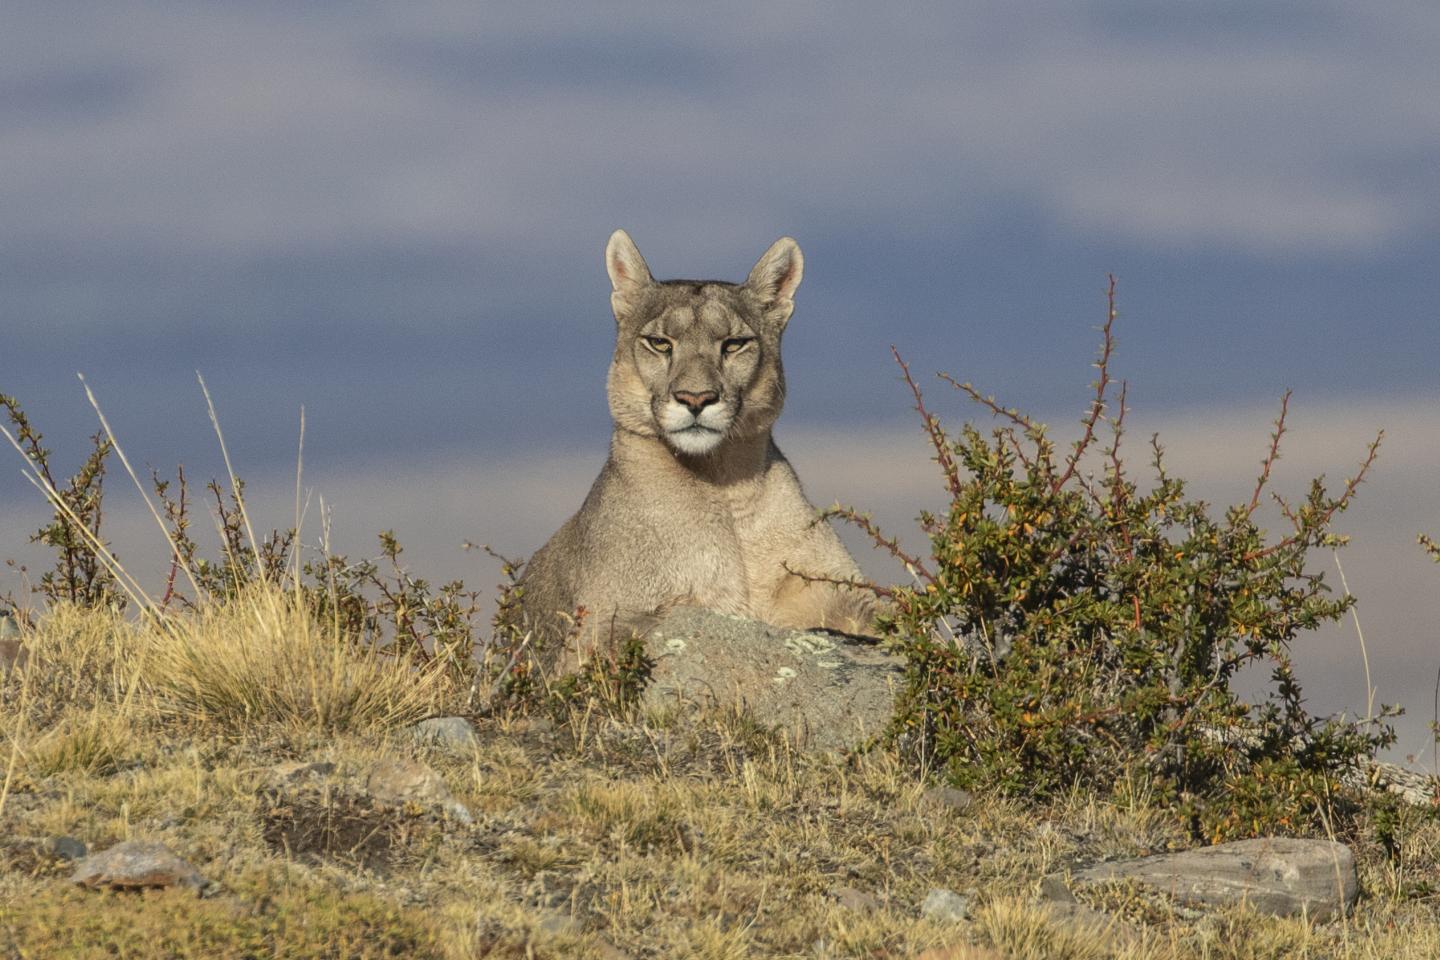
[0,604,1440,960]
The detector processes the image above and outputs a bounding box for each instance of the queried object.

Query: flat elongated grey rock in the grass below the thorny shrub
[1071,838,1359,920]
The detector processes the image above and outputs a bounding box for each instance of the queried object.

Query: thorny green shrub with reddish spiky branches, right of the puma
[828,279,1394,839]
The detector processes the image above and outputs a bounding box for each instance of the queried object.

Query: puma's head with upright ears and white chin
[605,230,805,456]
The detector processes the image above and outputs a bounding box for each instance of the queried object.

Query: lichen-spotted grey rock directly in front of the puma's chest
[645,607,901,751]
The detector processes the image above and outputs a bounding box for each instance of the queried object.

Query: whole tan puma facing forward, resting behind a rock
[521,230,873,653]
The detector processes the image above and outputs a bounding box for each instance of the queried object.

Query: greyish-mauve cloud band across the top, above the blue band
[0,1,1440,296]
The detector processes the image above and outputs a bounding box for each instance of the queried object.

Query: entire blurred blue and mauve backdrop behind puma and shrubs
[0,0,1440,759]
